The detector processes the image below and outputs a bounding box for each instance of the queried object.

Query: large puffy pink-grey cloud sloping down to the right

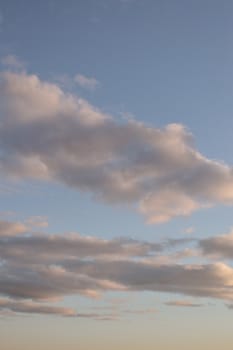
[0,72,233,223]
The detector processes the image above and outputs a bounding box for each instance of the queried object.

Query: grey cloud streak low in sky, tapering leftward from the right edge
[65,260,233,300]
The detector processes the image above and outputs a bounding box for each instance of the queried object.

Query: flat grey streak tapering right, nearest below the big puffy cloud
[0,231,163,265]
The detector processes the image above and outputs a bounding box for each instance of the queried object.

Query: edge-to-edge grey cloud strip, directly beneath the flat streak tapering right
[0,253,233,300]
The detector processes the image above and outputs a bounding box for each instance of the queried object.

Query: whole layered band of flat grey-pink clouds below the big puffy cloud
[0,221,233,318]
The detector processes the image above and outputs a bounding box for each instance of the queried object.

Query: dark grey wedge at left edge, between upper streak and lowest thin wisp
[0,265,125,300]
